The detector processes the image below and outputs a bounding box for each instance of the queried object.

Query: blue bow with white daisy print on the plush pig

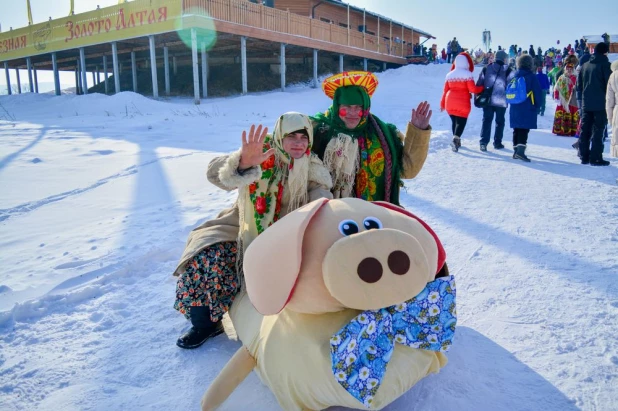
[330,276,457,408]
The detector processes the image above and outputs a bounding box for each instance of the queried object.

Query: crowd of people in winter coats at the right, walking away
[440,35,618,166]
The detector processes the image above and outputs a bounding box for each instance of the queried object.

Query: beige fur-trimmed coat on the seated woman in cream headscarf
[174,151,333,275]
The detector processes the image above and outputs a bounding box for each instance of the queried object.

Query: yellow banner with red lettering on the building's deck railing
[0,0,182,61]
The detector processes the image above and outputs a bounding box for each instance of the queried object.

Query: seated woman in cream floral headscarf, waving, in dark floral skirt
[174,112,332,348]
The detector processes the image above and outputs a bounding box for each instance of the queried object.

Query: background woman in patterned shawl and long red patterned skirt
[552,55,579,137]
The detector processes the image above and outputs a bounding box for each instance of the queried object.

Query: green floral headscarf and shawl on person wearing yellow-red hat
[311,86,403,205]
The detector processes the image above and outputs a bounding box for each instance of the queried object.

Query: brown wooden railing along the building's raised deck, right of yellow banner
[182,0,407,57]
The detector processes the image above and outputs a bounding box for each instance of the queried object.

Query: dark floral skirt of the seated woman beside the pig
[174,241,240,322]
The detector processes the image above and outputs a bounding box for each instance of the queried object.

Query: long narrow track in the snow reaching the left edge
[0,153,195,222]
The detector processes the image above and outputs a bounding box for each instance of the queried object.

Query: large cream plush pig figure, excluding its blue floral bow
[202,199,454,411]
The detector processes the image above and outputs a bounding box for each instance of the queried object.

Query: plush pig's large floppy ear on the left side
[243,198,328,315]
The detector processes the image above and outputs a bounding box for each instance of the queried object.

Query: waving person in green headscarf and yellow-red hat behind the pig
[311,73,432,205]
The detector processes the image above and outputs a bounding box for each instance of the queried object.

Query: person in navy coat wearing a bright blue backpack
[509,54,543,162]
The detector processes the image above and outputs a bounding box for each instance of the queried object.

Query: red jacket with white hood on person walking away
[440,53,484,118]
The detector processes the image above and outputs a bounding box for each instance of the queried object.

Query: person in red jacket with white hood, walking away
[440,52,484,152]
